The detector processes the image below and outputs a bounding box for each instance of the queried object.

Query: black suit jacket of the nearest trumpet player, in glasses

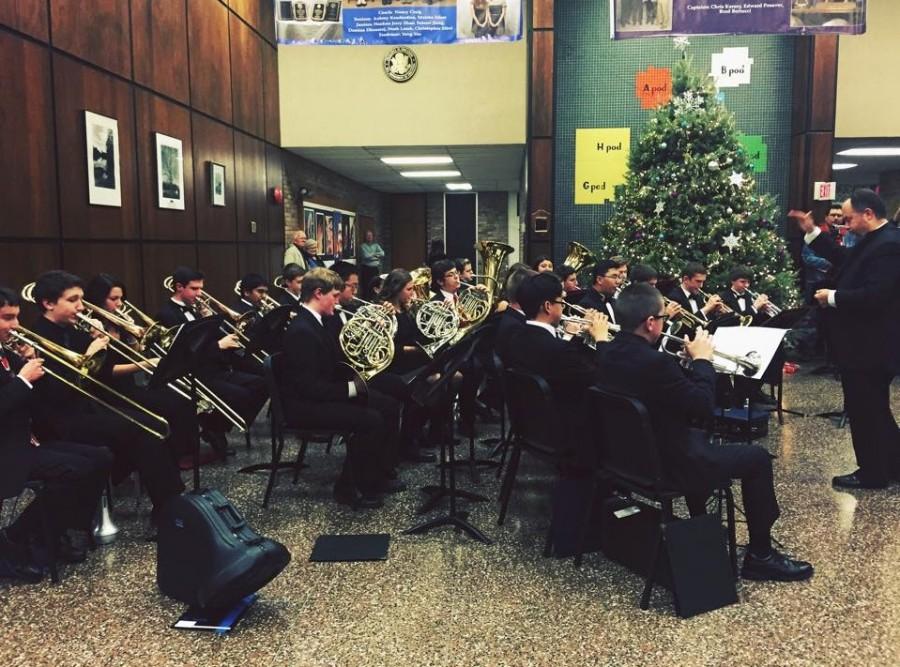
[600,332,722,489]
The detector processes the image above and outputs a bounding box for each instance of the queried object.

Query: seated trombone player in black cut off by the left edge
[0,287,113,583]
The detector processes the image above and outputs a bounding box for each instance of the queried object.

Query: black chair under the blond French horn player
[238,352,351,507]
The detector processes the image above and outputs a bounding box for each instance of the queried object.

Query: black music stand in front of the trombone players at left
[149,317,221,491]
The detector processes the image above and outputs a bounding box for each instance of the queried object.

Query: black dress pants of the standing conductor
[840,368,900,484]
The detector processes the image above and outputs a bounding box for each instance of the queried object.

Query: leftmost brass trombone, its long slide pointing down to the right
[5,328,169,440]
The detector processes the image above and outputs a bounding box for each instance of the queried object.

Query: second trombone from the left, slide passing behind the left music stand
[78,300,247,431]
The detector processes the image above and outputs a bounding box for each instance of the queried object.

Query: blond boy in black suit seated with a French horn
[279,268,402,508]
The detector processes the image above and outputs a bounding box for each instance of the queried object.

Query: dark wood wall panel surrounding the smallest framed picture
[192,113,237,241]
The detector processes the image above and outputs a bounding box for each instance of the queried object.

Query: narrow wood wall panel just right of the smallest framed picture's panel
[234,131,267,241]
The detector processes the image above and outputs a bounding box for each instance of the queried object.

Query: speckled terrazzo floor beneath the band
[0,375,900,667]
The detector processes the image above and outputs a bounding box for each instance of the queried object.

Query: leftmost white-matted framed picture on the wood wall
[84,111,122,206]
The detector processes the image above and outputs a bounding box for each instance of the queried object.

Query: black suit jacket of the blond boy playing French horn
[281,308,350,403]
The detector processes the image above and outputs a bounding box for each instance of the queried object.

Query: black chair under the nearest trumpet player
[575,387,737,609]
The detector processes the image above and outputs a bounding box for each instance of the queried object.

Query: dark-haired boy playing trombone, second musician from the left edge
[34,271,184,520]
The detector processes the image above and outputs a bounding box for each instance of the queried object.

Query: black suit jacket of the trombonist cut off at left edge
[0,350,37,498]
